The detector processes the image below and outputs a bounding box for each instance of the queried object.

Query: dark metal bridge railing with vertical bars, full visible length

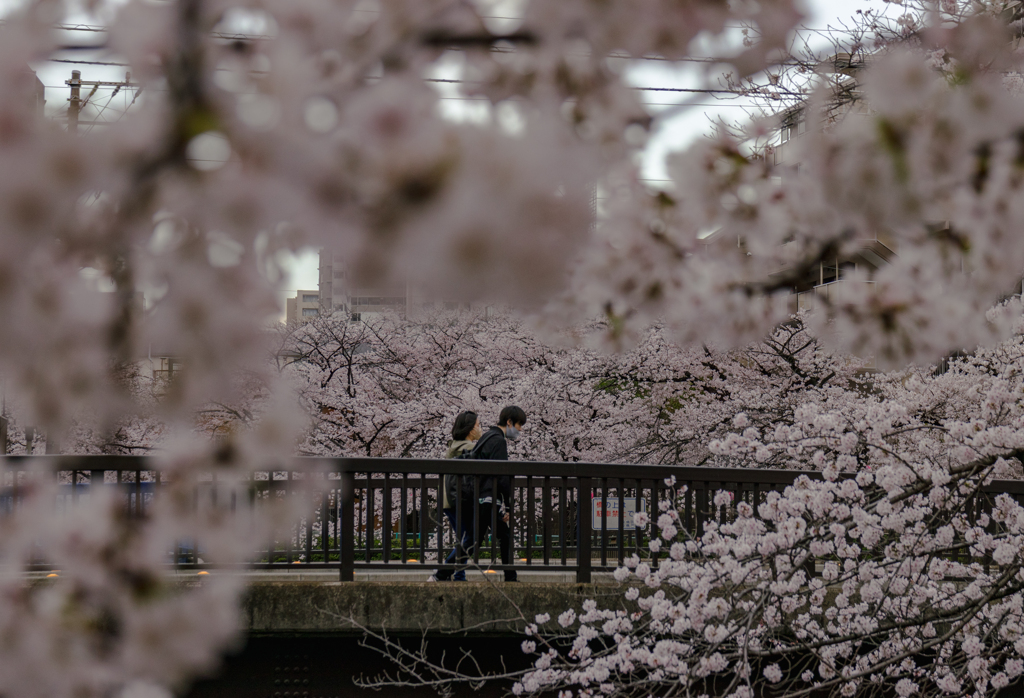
[0,455,1024,582]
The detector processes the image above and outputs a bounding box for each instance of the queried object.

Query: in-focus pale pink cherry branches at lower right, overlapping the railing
[364,321,1024,696]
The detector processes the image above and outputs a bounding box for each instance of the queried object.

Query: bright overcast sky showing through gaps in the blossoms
[0,0,884,296]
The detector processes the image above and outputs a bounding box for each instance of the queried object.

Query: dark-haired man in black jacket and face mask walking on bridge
[472,405,526,581]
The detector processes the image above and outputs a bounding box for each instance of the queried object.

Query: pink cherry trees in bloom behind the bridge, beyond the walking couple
[282,312,864,467]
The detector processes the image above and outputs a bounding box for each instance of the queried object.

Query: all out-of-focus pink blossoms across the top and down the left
[9,0,1024,696]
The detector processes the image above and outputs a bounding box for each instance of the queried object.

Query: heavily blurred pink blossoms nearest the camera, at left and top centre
[0,0,799,698]
